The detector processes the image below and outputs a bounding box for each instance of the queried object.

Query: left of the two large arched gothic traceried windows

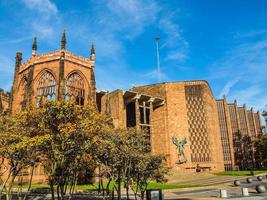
[37,71,56,106]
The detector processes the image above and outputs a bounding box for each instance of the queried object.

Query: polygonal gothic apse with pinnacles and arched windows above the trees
[11,37,96,112]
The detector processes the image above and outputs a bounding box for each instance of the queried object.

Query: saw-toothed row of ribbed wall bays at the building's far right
[217,97,262,170]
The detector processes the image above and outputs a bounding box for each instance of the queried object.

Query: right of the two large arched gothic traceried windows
[65,73,84,105]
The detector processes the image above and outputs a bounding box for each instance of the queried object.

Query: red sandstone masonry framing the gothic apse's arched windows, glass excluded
[12,51,96,112]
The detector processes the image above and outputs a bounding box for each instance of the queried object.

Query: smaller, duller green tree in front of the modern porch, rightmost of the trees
[95,128,168,199]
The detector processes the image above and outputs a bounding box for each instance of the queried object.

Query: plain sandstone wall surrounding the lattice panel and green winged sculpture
[132,81,224,171]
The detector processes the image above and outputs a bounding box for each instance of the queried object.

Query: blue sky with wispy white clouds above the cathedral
[0,0,267,110]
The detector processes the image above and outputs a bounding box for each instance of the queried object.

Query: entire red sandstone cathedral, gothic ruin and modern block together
[0,32,262,171]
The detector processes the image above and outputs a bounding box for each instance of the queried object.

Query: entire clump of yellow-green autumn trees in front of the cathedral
[0,101,168,199]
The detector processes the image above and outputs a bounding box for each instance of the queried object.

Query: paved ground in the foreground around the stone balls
[16,172,267,200]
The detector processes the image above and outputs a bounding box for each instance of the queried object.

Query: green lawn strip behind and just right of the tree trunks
[18,182,201,190]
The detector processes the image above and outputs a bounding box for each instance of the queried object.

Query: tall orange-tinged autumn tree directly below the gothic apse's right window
[41,101,111,199]
